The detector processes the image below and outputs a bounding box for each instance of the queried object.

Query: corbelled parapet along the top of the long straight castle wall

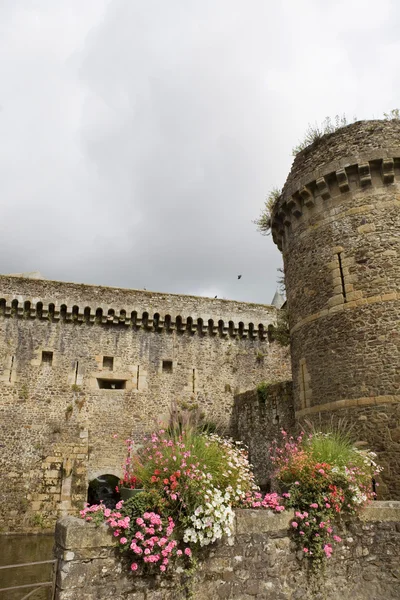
[0,276,277,339]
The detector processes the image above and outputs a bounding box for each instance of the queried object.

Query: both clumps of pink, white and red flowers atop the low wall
[81,427,379,573]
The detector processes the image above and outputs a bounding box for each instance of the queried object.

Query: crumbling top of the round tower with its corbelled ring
[271,121,400,250]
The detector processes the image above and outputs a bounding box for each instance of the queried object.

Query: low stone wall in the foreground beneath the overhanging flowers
[55,502,400,600]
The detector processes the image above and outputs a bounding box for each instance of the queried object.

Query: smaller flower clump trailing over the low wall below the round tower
[270,431,381,562]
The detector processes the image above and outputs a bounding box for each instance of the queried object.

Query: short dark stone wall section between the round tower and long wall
[232,381,295,490]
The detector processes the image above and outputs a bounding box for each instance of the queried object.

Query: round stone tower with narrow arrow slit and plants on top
[271,120,400,499]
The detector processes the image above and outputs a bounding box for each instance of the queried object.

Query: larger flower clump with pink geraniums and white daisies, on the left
[81,426,284,573]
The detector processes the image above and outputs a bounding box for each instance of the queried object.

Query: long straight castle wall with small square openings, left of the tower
[0,276,290,530]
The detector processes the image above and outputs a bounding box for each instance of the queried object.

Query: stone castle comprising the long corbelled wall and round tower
[0,121,400,529]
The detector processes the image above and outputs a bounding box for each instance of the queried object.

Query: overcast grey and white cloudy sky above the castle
[0,0,400,303]
